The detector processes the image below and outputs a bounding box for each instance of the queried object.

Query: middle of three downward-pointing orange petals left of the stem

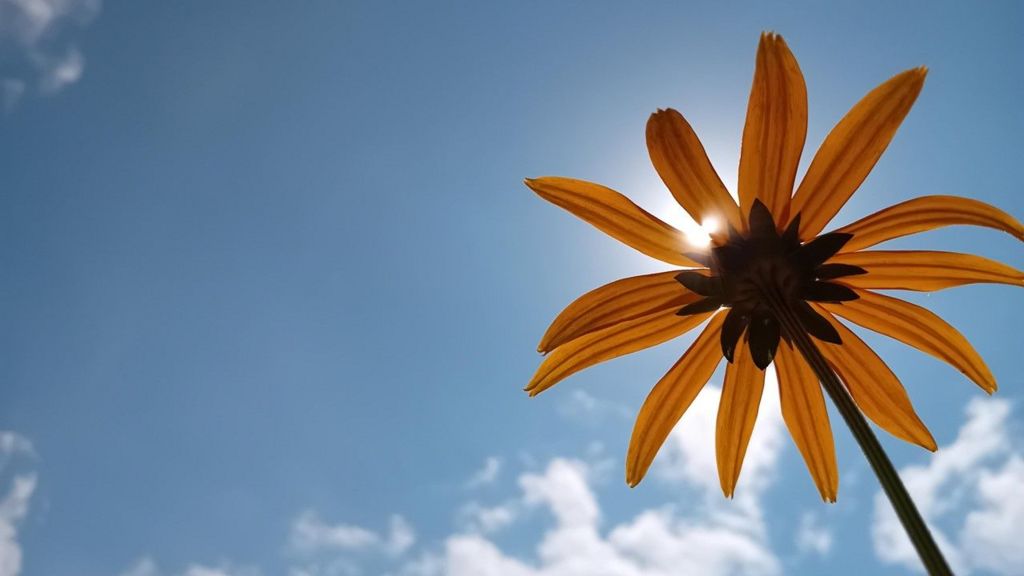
[715,338,765,498]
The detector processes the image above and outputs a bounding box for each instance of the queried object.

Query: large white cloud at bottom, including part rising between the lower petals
[387,378,782,576]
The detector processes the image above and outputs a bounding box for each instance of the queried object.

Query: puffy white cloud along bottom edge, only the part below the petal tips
[400,458,781,576]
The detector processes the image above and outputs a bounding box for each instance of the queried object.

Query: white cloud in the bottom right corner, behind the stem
[871,399,1024,575]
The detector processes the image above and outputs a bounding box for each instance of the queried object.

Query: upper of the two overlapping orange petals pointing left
[537,271,701,353]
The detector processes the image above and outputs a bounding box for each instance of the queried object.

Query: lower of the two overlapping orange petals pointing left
[525,308,711,396]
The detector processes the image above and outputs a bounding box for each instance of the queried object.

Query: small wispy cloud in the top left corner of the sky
[0,0,100,103]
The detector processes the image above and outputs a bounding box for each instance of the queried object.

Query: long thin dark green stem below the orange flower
[770,298,952,576]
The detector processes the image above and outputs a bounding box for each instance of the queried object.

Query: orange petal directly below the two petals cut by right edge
[820,290,996,394]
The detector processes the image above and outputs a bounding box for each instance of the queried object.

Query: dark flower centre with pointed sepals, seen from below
[676,200,865,370]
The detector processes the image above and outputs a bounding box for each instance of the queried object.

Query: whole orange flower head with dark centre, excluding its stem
[526,34,1024,501]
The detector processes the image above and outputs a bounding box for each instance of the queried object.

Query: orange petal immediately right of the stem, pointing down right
[812,304,936,452]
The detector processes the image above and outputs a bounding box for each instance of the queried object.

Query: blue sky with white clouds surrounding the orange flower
[0,0,1024,576]
